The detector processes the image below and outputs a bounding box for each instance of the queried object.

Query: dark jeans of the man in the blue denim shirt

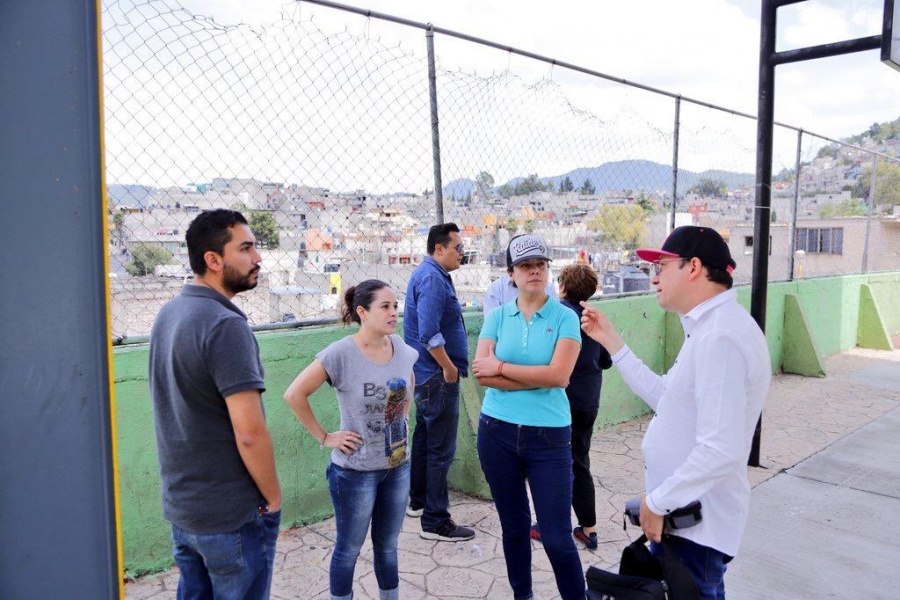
[409,373,459,529]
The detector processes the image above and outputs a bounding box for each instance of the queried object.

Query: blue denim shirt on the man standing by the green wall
[403,256,469,385]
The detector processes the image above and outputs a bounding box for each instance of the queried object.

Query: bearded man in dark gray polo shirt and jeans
[150,209,281,599]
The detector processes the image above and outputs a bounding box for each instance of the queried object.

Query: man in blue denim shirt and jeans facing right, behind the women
[403,223,475,542]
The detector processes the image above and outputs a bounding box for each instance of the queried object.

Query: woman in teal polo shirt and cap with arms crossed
[473,235,585,600]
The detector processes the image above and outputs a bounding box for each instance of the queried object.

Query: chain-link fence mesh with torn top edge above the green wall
[103,0,900,339]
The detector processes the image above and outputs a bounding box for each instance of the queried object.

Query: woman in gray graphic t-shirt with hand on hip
[284,279,418,599]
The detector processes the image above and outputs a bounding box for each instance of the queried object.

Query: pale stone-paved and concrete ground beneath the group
[126,349,900,600]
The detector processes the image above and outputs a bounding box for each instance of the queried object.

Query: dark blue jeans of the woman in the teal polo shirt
[478,414,584,600]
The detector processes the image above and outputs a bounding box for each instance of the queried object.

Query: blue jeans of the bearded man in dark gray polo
[172,511,281,600]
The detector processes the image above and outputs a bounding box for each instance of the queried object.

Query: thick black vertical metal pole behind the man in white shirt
[748,0,777,467]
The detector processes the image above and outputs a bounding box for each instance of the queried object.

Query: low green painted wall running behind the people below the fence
[114,273,900,574]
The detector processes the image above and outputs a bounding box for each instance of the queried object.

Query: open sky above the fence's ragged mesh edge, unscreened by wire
[182,0,900,137]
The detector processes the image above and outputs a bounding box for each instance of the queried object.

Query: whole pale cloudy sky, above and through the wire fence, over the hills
[104,0,900,193]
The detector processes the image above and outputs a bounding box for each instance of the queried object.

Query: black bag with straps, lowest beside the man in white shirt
[586,535,700,600]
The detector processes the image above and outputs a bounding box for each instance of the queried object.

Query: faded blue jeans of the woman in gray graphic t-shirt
[325,462,409,599]
